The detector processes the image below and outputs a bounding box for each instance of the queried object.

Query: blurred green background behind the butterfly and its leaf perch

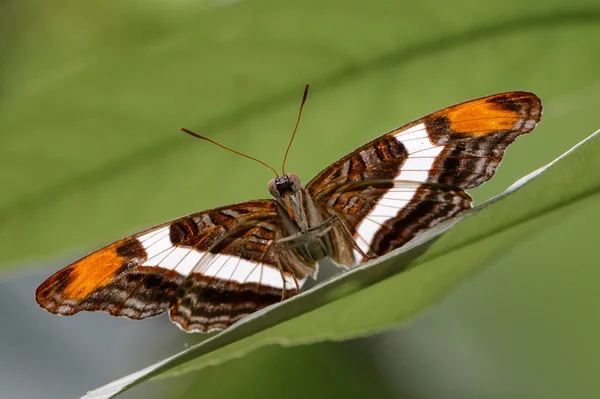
[0,0,600,399]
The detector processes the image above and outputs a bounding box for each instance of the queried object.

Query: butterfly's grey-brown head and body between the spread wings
[269,173,333,261]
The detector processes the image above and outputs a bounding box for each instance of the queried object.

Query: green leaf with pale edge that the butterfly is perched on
[85,131,600,398]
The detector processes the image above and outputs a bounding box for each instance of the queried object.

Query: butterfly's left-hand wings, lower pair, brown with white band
[36,200,316,332]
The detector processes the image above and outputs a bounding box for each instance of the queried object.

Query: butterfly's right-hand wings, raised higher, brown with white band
[307,92,542,266]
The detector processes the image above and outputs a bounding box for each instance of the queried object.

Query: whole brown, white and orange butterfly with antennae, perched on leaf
[36,85,542,332]
